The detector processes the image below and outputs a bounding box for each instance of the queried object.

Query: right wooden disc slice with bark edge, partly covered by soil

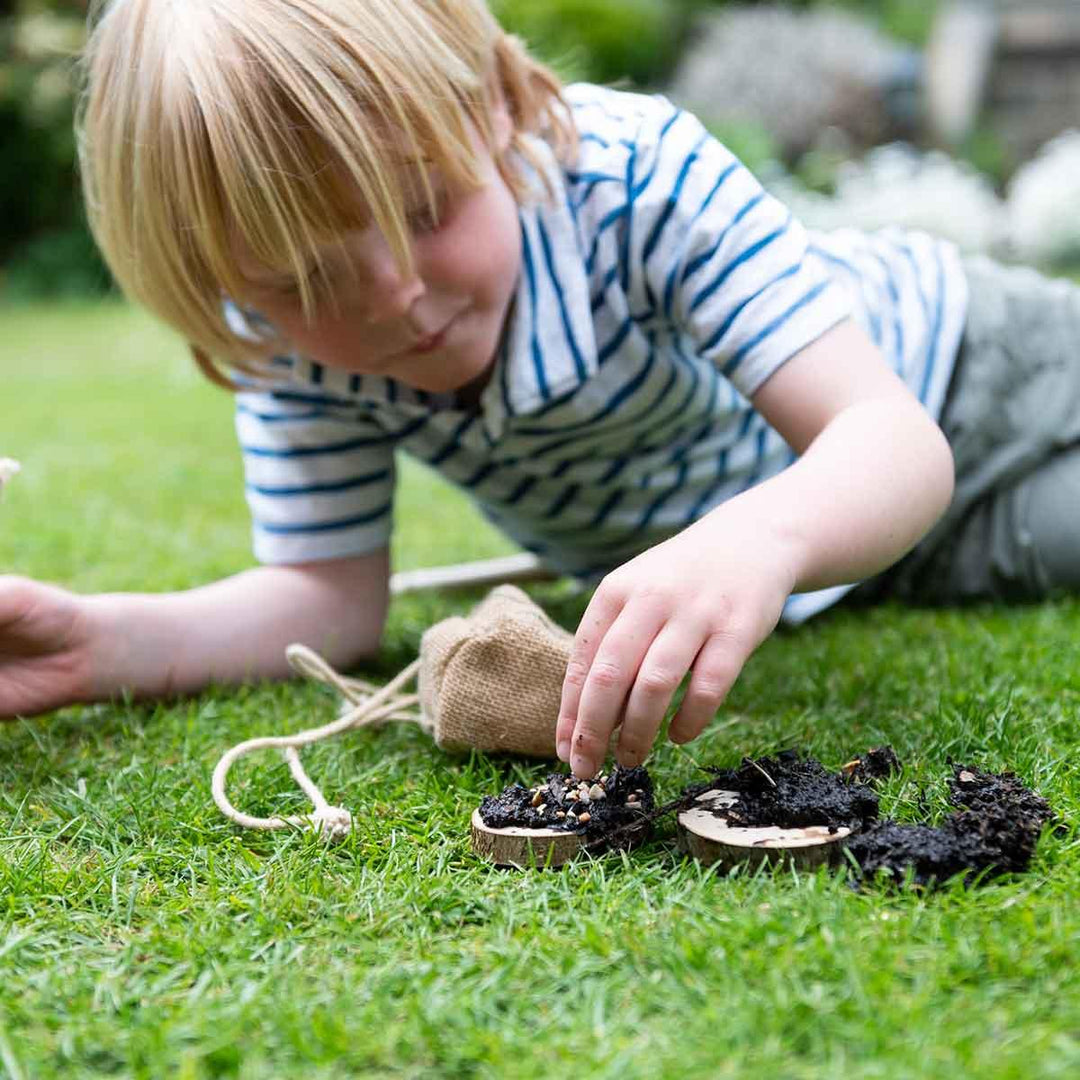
[678,788,851,866]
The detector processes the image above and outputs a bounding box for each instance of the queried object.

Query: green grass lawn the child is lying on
[0,306,1080,1078]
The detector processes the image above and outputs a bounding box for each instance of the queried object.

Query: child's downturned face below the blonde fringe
[238,113,521,393]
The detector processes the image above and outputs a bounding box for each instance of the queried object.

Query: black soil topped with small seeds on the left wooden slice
[480,766,656,848]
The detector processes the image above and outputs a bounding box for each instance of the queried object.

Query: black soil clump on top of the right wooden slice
[692,748,895,833]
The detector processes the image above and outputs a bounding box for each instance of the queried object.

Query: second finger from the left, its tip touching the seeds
[570,605,662,777]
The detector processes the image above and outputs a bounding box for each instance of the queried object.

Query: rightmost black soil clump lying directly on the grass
[846,766,1053,887]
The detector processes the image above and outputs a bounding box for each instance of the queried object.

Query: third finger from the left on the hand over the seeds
[616,623,702,768]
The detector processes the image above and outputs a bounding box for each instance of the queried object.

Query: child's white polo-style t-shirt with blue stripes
[234,85,967,619]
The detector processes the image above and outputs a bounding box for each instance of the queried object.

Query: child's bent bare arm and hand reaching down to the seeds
[557,322,953,777]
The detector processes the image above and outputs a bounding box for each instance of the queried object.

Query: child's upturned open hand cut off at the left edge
[0,576,91,719]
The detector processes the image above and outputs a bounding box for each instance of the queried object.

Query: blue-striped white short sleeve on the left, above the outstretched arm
[237,390,395,564]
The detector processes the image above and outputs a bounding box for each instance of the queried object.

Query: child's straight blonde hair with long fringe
[77,0,576,387]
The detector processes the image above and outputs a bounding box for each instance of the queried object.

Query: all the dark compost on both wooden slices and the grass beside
[480,746,1054,887]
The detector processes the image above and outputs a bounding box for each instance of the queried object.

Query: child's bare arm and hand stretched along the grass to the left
[0,551,389,717]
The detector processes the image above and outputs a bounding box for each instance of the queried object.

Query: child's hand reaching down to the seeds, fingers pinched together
[556,508,795,777]
